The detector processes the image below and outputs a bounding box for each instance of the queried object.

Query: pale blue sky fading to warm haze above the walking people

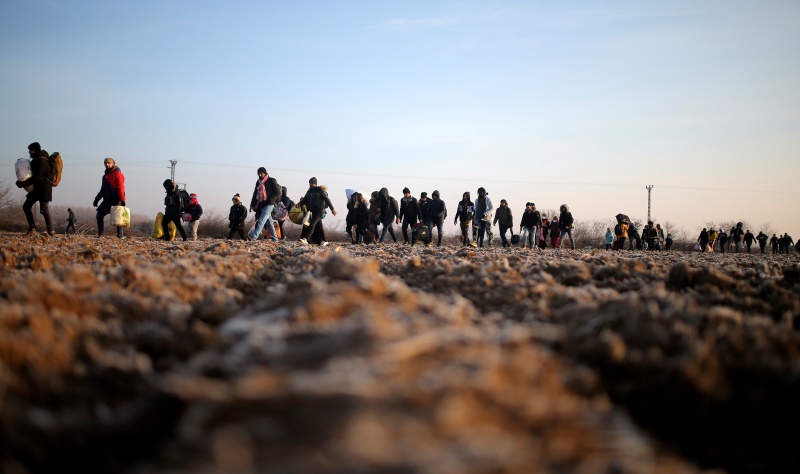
[0,0,800,237]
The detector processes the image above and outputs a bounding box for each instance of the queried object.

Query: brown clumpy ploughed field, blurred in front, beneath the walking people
[0,234,800,474]
